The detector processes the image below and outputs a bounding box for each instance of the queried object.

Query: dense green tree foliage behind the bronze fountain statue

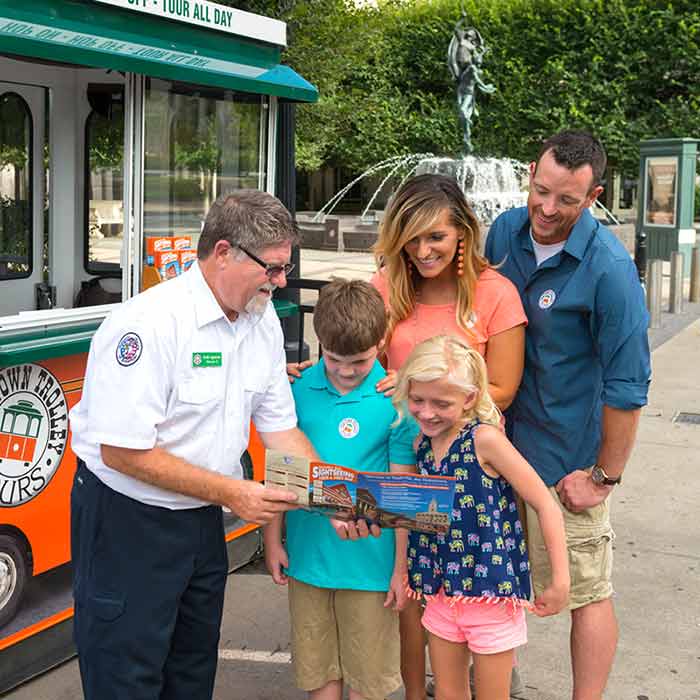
[220,0,700,174]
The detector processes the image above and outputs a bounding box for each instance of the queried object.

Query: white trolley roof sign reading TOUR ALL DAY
[95,0,287,46]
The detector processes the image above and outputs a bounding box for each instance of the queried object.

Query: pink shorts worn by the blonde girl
[422,591,527,654]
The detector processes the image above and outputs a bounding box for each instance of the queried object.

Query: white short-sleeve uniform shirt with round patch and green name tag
[70,264,297,509]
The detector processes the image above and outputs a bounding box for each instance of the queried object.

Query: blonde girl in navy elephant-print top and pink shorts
[393,336,569,700]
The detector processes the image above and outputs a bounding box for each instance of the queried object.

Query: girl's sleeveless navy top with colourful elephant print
[408,420,530,607]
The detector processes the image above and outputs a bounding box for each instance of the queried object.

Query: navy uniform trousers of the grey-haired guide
[71,460,228,700]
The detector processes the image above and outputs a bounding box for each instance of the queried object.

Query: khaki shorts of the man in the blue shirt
[526,486,615,610]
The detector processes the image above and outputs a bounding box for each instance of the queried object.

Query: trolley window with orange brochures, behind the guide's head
[142,79,268,288]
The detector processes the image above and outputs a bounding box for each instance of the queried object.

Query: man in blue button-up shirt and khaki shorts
[486,131,650,700]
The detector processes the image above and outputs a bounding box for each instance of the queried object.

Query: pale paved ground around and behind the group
[6,251,700,700]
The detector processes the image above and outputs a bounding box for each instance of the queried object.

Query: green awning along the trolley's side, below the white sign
[0,0,318,102]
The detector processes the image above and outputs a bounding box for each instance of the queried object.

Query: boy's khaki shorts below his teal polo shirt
[289,578,401,700]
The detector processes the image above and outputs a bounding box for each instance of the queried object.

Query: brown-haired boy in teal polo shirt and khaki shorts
[265,280,417,700]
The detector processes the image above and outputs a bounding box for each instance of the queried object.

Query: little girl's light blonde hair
[392,335,501,426]
